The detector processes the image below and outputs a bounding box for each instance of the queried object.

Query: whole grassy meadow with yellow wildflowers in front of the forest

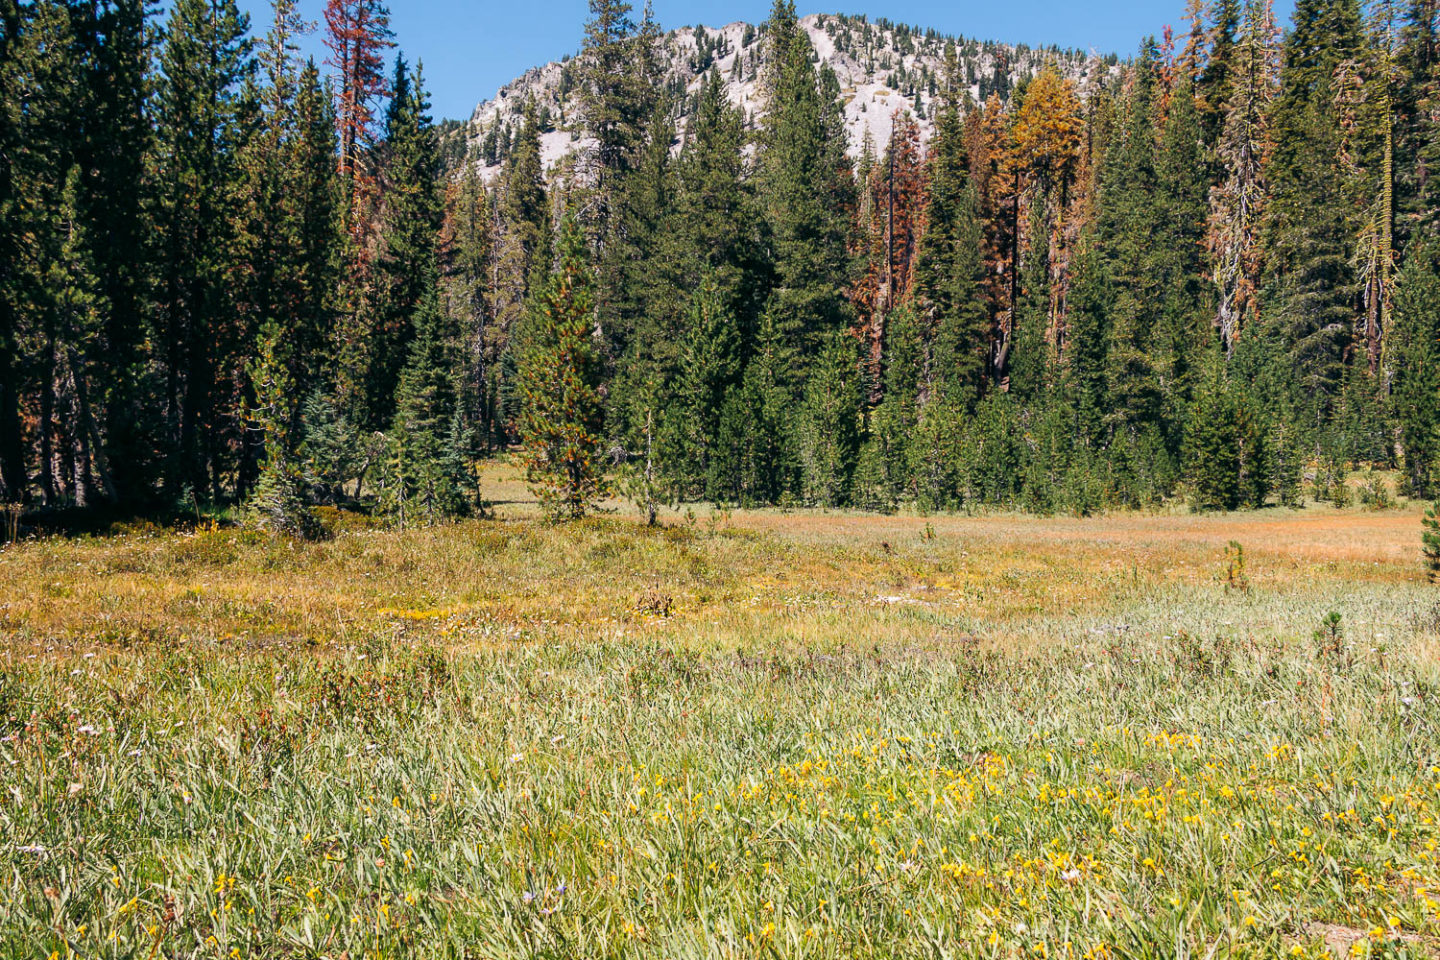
[0,478,1440,960]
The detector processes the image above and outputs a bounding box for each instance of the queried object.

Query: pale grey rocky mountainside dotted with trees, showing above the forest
[464,14,1116,178]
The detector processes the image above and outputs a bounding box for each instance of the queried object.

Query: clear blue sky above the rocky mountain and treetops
[227,0,1293,118]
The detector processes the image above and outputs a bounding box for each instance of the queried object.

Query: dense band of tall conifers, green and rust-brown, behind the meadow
[0,0,1440,534]
